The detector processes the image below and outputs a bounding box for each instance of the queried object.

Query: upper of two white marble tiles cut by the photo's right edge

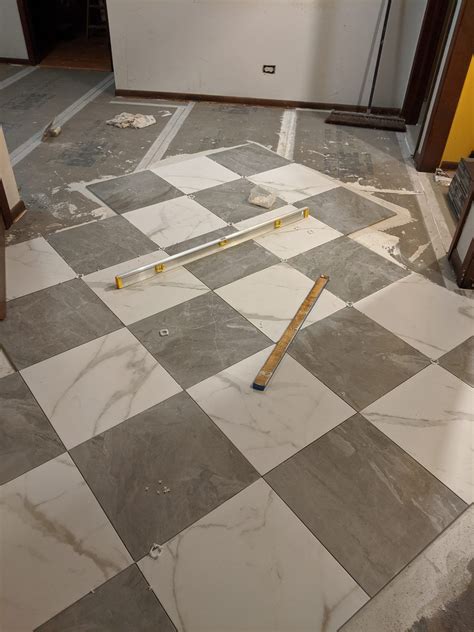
[355,274,474,359]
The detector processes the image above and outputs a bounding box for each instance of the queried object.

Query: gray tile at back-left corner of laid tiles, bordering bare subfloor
[87,171,183,213]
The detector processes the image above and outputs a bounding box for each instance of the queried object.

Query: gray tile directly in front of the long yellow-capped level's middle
[186,241,280,290]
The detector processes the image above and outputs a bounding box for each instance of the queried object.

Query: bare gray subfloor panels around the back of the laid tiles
[0,68,454,292]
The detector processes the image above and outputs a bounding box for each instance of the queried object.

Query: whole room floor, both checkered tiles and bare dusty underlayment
[0,65,474,632]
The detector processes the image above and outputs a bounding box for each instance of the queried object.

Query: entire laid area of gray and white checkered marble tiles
[0,144,474,632]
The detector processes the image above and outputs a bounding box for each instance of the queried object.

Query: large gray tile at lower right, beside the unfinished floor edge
[266,415,466,595]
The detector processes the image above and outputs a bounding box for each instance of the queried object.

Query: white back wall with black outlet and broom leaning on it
[107,0,427,107]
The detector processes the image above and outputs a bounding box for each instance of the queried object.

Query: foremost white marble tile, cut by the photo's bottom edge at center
[139,480,367,632]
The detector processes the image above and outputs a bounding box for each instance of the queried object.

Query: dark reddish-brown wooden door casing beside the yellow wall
[414,0,474,171]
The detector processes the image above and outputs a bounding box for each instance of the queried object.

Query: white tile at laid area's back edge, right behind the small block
[249,163,339,204]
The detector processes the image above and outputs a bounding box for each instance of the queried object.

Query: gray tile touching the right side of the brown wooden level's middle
[290,308,429,410]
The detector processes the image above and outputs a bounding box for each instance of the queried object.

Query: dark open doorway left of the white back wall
[18,0,112,71]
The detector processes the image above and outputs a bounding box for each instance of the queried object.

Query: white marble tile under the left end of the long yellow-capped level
[83,250,209,325]
